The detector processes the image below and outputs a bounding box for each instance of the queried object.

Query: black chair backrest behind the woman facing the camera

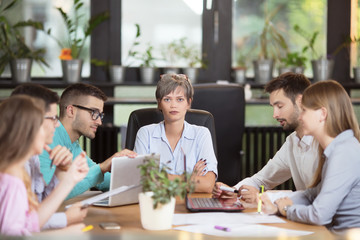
[125,108,217,156]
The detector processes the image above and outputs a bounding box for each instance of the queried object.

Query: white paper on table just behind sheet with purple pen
[173,212,285,225]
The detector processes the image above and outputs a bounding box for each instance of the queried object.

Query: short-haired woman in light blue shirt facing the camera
[134,74,217,193]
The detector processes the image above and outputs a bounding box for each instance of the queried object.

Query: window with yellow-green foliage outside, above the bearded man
[232,0,327,77]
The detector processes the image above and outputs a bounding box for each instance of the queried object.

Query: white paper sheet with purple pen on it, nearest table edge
[174,224,313,238]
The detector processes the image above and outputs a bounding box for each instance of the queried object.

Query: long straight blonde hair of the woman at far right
[301,80,360,187]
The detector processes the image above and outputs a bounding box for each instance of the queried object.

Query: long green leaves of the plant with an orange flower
[52,0,109,59]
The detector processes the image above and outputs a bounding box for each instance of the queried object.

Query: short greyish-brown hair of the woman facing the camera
[155,73,194,102]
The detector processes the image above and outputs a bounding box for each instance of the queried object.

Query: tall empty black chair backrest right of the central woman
[192,83,245,185]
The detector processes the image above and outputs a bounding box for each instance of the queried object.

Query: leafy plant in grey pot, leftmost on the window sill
[0,0,49,82]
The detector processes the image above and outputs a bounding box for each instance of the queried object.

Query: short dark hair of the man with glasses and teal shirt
[60,83,107,117]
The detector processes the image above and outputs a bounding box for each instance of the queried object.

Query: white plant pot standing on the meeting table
[139,192,175,230]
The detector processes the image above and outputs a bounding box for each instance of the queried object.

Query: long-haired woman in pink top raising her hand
[0,96,89,236]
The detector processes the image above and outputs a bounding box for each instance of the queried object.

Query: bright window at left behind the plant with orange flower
[2,0,90,77]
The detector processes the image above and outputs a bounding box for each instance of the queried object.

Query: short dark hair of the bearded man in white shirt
[265,72,311,104]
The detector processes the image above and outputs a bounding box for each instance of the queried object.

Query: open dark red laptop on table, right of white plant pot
[181,148,244,212]
